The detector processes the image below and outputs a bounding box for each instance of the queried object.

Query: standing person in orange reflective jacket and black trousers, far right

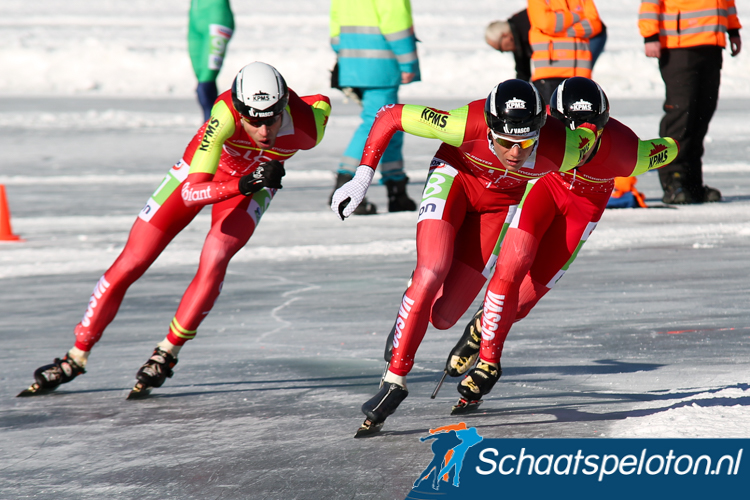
[638,0,742,204]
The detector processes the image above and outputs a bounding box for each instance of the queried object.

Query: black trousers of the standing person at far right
[658,45,722,199]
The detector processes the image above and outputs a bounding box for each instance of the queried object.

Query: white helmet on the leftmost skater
[232,62,289,118]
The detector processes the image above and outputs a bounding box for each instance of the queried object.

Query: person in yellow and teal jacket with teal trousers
[329,0,421,215]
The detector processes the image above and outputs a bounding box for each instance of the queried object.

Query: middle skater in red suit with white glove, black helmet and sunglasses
[331,80,595,436]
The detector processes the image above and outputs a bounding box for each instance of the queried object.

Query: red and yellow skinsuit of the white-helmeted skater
[75,90,331,351]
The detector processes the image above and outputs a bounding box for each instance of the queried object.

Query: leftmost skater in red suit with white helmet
[19,62,331,397]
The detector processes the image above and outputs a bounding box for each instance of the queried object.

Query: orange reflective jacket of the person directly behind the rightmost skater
[528,0,602,80]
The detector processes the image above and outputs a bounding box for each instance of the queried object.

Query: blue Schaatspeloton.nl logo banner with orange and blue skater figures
[406,422,750,500]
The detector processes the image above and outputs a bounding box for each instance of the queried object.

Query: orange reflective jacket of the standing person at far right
[638,0,742,49]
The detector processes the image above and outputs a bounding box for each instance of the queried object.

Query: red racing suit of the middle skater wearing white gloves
[361,99,594,375]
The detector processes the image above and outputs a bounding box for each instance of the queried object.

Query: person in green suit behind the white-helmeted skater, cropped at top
[188,0,234,121]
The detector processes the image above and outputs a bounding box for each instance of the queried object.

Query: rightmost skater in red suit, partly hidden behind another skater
[446,77,679,412]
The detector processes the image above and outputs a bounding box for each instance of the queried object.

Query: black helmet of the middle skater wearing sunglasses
[484,80,547,135]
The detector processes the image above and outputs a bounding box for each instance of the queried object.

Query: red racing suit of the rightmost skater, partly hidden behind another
[480,119,679,363]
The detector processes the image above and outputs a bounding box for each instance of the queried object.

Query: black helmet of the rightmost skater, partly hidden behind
[549,76,609,130]
